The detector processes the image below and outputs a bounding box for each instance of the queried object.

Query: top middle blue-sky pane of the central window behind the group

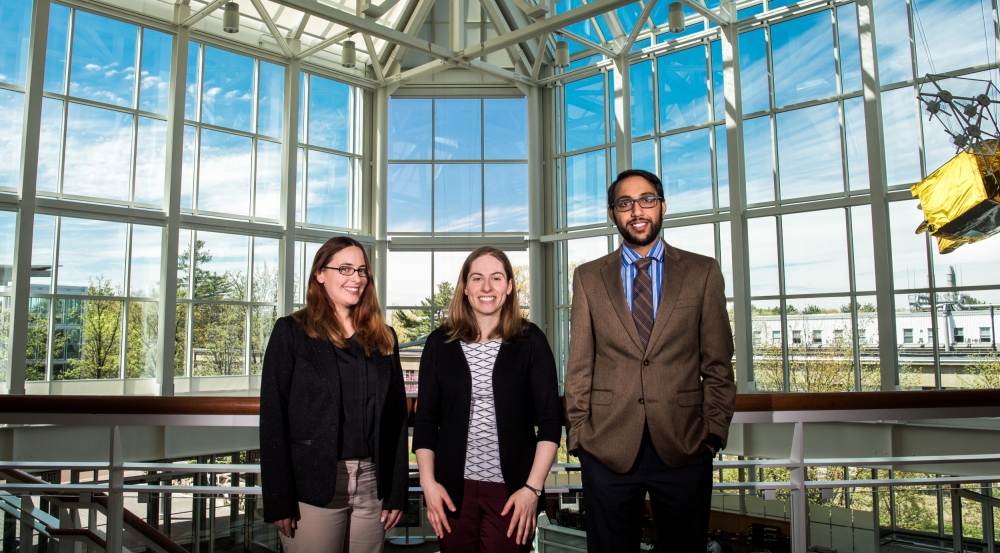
[434,100,483,159]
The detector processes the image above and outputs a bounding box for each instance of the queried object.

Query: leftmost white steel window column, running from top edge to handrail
[7,0,51,395]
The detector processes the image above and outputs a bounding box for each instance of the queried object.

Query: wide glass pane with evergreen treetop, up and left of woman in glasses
[194,231,248,301]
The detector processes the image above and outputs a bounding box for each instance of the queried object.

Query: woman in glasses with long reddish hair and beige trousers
[260,237,408,553]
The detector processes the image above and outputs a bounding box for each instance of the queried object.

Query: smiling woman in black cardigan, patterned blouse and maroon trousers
[413,246,562,553]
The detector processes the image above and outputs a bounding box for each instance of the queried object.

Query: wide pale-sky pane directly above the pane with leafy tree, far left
[57,217,128,296]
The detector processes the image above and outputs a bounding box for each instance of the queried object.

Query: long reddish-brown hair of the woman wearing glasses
[292,236,395,355]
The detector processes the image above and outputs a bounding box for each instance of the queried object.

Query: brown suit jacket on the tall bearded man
[565,239,736,473]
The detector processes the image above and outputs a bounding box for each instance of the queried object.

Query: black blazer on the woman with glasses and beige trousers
[260,317,409,522]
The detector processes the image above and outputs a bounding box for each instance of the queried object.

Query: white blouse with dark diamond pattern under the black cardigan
[462,340,503,482]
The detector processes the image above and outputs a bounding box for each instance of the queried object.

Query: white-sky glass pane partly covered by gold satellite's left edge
[889,200,928,290]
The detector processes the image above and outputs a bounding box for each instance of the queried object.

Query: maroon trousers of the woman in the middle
[441,480,531,553]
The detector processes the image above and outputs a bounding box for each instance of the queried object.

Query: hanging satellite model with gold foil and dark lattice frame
[910,75,1000,254]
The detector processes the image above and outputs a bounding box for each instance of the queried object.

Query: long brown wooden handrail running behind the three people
[0,390,1000,415]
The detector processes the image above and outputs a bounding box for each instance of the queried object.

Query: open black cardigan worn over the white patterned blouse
[413,324,563,517]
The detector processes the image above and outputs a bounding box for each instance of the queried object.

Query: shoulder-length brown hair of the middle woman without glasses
[441,246,528,344]
